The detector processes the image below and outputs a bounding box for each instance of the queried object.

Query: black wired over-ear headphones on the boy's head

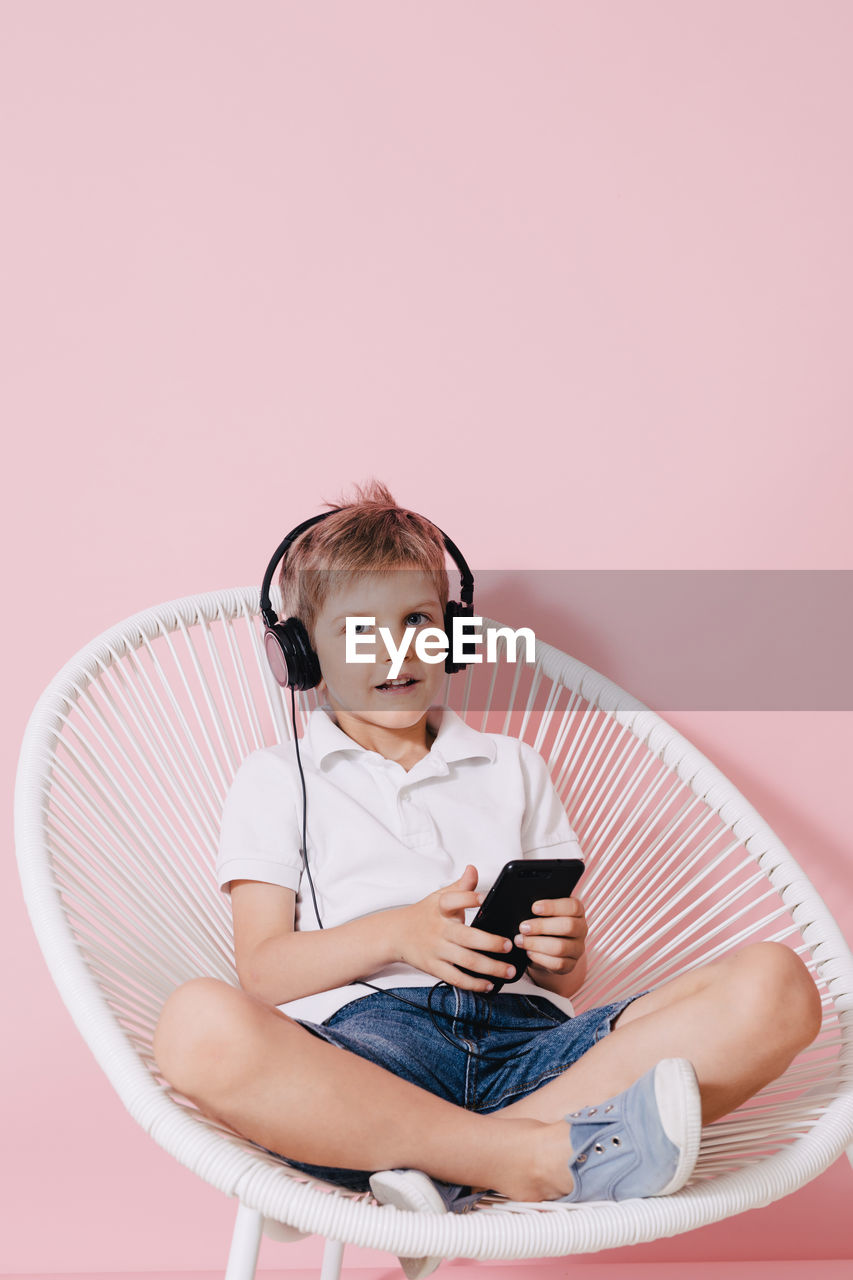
[260,507,474,689]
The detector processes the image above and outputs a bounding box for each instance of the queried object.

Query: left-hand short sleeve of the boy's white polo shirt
[216,748,302,892]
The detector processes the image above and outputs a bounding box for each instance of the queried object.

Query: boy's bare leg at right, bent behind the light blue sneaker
[498,942,821,1124]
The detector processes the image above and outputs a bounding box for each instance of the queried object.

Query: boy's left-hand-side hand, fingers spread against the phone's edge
[394,865,515,991]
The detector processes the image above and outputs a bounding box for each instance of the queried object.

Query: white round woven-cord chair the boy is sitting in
[15,588,853,1280]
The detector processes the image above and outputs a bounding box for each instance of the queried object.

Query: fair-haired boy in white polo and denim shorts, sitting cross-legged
[155,483,821,1275]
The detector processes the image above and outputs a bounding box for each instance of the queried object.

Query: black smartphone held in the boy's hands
[456,858,584,991]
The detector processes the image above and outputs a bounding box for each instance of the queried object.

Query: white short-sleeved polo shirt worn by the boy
[216,707,583,1023]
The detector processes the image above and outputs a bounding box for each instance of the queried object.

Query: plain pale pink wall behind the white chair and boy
[0,0,853,1272]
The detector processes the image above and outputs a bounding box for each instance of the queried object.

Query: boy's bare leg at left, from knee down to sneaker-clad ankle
[154,978,573,1199]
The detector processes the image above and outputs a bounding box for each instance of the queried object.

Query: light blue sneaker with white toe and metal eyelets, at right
[560,1057,702,1203]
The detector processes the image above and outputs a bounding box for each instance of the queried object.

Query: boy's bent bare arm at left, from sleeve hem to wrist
[231,881,394,1005]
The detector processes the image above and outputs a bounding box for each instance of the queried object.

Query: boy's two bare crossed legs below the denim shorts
[155,943,821,1201]
